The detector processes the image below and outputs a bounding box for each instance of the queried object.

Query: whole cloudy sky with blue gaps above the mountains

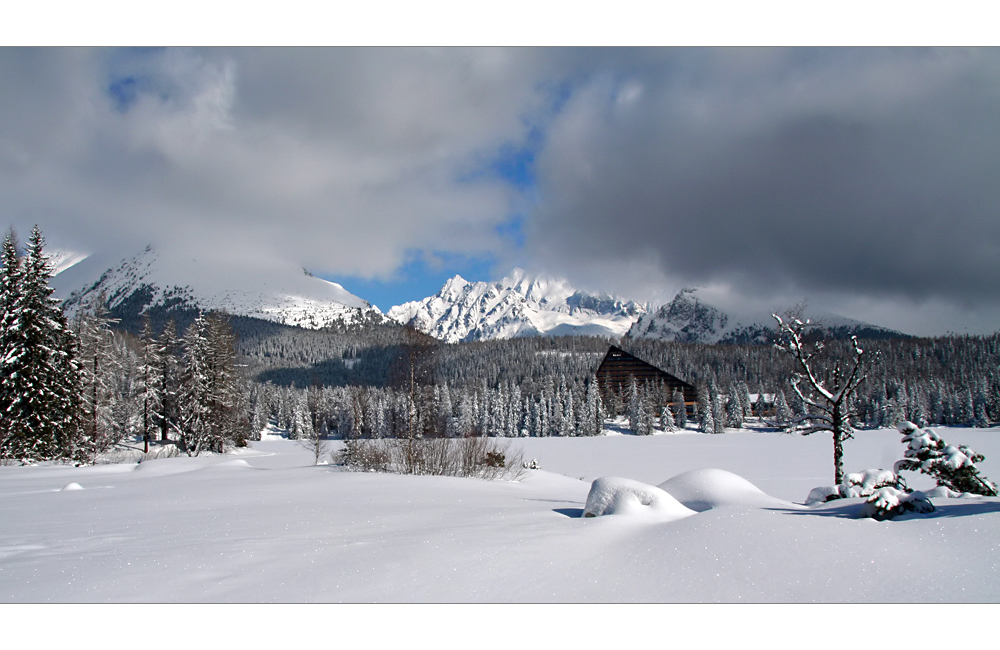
[0,40,1000,335]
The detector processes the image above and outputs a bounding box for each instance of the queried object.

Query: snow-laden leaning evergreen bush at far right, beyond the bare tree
[894,421,998,497]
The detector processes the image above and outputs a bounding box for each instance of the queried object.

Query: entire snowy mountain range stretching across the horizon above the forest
[50,246,906,343]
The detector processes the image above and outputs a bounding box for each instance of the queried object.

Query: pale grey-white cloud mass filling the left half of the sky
[0,48,556,275]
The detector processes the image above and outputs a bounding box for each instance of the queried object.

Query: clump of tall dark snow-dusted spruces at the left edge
[0,226,79,462]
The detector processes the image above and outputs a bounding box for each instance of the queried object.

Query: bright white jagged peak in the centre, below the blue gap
[388,269,647,343]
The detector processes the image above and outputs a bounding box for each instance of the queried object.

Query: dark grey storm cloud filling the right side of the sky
[533,49,1000,302]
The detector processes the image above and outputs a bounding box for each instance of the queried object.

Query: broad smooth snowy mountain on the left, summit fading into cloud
[50,246,380,329]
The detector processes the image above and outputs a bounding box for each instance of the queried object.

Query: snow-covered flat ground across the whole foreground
[0,428,1000,603]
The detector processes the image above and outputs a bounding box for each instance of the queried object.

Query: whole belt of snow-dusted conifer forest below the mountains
[0,225,1000,462]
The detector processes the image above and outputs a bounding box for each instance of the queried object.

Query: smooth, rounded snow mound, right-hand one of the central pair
[659,469,788,512]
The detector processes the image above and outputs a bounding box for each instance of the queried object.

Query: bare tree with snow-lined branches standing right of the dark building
[771,310,865,485]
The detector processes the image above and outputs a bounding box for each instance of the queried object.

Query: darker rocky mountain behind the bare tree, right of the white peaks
[626,289,908,343]
